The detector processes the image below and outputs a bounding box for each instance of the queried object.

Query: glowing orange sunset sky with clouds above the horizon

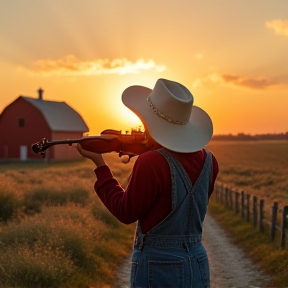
[0,0,288,135]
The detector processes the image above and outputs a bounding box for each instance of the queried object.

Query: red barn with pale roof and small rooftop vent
[0,89,89,161]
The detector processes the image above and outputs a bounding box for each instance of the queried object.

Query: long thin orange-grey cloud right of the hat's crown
[192,73,288,90]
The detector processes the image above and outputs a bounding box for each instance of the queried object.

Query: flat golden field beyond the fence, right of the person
[207,140,288,205]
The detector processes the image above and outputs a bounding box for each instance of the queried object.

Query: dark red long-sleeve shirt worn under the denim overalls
[94,150,218,233]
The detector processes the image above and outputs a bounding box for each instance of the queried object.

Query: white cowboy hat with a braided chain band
[122,79,213,153]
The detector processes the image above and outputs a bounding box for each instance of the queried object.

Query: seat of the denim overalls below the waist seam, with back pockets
[130,243,210,288]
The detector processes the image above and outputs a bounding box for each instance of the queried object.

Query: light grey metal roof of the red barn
[20,96,89,132]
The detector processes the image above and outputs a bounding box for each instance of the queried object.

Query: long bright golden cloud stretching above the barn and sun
[17,55,166,76]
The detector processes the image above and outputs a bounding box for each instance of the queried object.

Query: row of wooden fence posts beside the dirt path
[214,183,288,250]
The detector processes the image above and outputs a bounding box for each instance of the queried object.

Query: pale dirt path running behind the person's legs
[116,215,272,288]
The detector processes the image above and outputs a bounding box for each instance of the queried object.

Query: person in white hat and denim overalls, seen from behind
[77,79,218,288]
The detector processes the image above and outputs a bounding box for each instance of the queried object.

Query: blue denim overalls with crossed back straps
[130,148,212,288]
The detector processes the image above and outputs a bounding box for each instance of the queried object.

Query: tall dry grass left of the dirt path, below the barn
[0,155,134,288]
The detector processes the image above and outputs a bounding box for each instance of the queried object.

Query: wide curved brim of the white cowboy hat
[122,86,213,153]
